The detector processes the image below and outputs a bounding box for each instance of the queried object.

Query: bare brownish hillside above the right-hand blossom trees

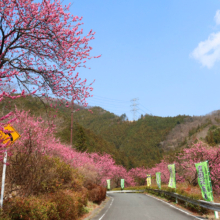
[160,110,220,151]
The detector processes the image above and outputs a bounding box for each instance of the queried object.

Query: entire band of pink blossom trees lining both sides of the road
[9,109,220,192]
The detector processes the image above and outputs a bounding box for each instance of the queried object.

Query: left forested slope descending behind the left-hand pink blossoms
[0,96,132,167]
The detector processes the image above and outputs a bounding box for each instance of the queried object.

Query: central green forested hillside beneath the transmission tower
[74,107,187,166]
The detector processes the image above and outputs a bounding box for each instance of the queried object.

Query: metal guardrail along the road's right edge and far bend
[107,189,220,212]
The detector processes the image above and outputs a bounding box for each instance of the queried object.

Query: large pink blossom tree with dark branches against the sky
[0,0,99,159]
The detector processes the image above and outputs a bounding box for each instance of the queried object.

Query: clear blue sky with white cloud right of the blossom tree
[63,0,220,120]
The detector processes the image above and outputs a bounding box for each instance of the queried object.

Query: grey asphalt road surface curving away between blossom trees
[92,193,203,220]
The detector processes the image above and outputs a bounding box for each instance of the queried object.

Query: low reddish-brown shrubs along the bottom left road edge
[0,188,88,220]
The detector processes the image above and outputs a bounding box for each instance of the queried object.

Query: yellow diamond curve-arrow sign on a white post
[0,125,20,209]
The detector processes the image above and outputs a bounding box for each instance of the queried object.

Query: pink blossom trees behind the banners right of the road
[140,141,220,193]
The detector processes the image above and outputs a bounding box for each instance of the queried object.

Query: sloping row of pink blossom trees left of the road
[8,109,135,186]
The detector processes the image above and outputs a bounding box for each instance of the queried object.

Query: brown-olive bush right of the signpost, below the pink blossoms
[6,153,78,197]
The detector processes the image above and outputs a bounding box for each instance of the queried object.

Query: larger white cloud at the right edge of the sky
[191,32,220,68]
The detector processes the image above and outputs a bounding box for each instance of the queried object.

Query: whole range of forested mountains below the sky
[0,96,220,169]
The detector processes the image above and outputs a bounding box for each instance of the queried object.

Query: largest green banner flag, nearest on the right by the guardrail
[195,161,214,202]
